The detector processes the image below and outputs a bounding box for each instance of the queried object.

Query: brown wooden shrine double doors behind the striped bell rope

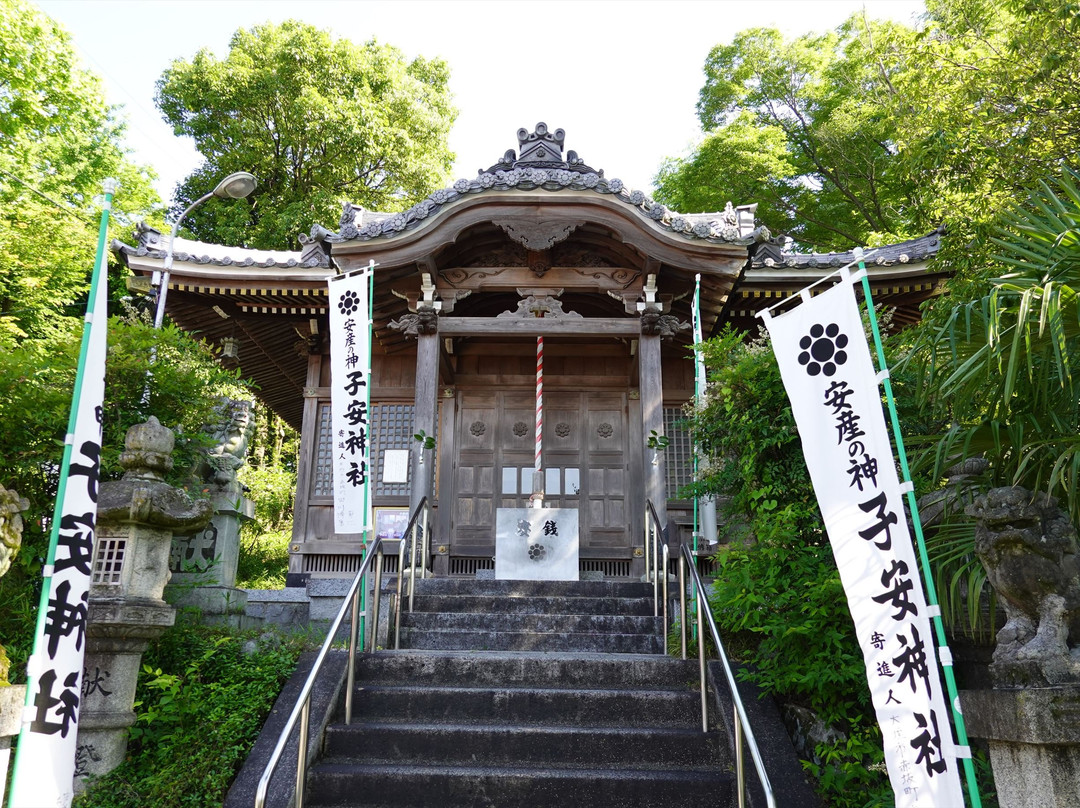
[450,390,632,557]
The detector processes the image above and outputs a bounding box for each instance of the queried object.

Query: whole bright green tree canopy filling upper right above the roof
[658,0,1080,271]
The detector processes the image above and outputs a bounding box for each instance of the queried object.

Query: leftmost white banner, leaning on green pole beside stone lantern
[9,180,117,808]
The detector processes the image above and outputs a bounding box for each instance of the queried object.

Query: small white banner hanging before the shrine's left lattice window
[329,264,375,533]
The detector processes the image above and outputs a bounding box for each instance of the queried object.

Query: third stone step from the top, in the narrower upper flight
[402,604,663,635]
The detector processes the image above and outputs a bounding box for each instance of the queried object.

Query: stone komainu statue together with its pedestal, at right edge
[961,487,1080,808]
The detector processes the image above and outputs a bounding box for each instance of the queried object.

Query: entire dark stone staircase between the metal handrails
[305,578,733,808]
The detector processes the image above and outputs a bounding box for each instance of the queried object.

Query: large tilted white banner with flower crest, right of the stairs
[765,270,963,808]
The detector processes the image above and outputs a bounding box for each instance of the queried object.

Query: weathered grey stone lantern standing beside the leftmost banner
[76,416,213,778]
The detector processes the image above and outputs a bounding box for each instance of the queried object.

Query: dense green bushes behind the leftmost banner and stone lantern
[0,317,243,673]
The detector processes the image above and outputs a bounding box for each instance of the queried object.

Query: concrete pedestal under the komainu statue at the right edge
[960,686,1080,808]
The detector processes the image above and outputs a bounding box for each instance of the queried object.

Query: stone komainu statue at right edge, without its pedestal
[964,486,1080,681]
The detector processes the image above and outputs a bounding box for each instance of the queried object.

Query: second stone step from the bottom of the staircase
[324,722,720,768]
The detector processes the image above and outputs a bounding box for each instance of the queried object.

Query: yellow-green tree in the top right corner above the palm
[895,0,1080,283]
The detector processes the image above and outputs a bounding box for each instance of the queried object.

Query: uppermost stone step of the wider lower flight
[356,650,698,690]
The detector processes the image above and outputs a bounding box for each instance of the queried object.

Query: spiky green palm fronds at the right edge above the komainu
[908,170,1080,524]
